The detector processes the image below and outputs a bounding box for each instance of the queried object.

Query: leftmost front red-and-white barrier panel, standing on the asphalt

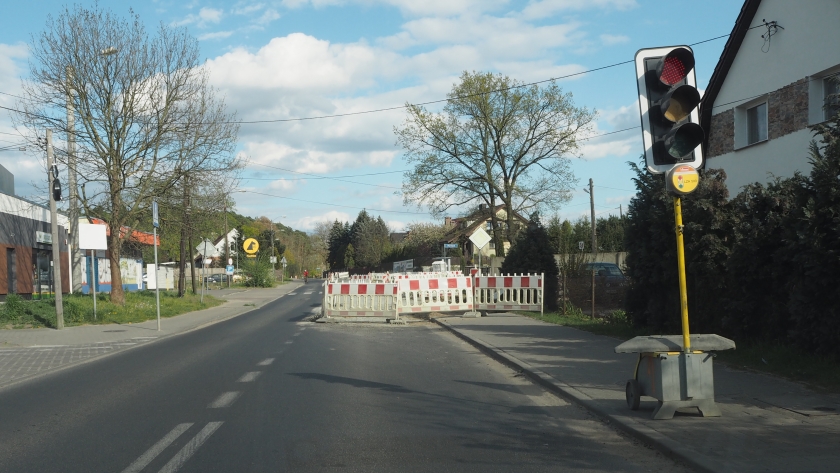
[323,282,397,318]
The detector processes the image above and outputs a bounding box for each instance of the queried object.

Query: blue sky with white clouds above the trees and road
[0,0,744,231]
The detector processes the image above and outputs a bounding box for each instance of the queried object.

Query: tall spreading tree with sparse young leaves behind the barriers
[394,72,595,253]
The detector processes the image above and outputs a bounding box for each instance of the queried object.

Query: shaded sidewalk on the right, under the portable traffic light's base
[434,314,840,472]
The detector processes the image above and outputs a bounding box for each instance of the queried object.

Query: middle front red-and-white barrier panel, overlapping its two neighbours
[397,276,473,314]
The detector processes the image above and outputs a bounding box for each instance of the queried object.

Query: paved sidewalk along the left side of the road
[0,283,303,389]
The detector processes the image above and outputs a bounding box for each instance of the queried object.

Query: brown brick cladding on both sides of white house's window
[706,78,808,159]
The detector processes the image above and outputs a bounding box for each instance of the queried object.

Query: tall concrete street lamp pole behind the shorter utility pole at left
[66,66,82,293]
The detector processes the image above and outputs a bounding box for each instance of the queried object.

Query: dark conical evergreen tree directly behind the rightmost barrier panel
[502,213,560,310]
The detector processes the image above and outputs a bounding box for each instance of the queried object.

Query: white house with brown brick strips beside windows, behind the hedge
[700,0,840,195]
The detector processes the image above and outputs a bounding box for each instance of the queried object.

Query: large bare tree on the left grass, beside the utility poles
[16,5,238,304]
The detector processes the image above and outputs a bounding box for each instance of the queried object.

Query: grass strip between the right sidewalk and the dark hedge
[519,307,840,394]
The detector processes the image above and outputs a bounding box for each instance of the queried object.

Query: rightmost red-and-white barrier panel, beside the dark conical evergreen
[475,274,544,313]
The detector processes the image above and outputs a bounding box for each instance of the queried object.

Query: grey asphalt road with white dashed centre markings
[0,285,686,472]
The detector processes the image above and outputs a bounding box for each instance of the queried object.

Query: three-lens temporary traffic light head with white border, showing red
[636,46,705,174]
